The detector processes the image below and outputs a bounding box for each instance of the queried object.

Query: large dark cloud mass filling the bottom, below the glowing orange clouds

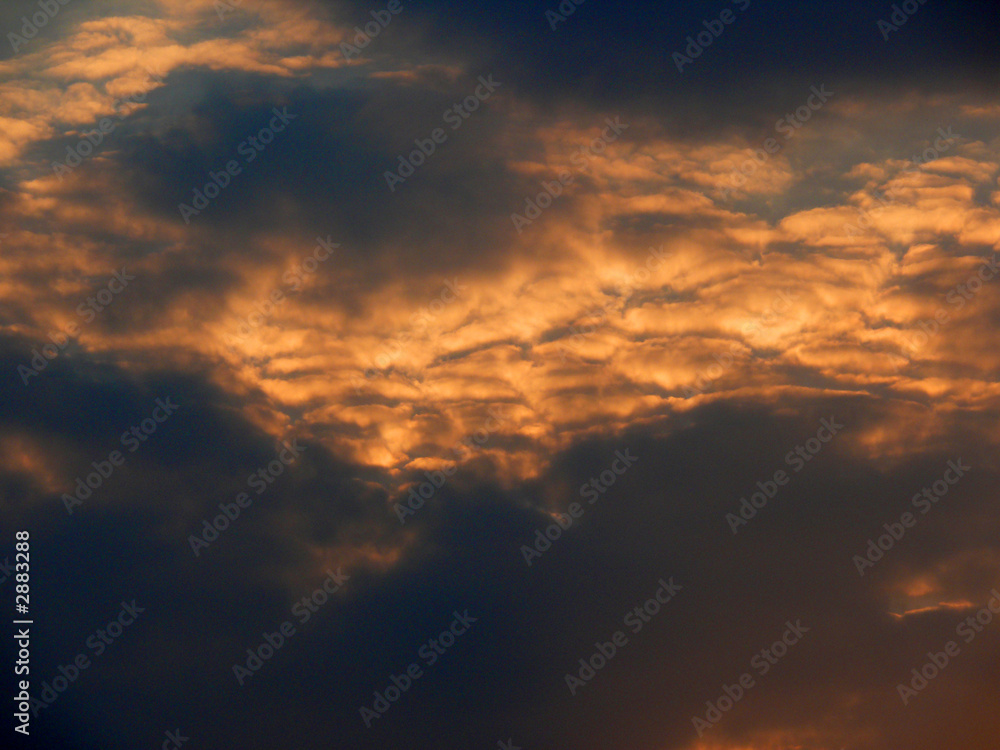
[3,334,997,748]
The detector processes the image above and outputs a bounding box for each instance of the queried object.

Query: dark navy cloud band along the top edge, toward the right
[333,0,997,135]
